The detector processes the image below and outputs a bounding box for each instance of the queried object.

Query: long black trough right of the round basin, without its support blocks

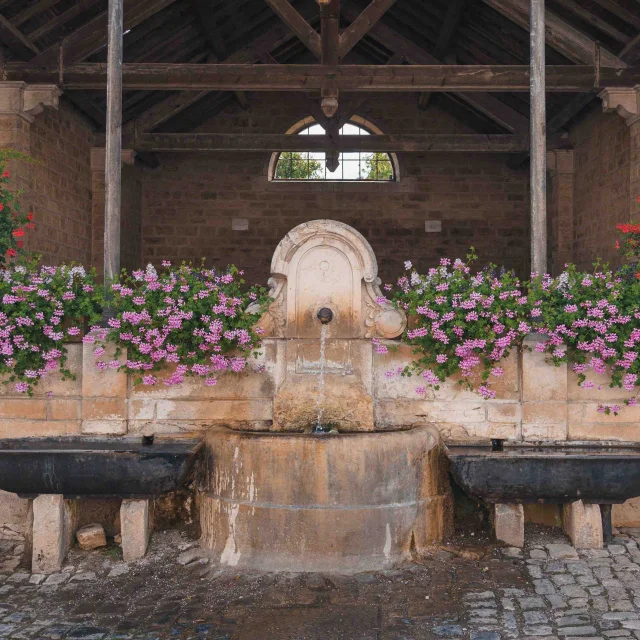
[445,442,640,504]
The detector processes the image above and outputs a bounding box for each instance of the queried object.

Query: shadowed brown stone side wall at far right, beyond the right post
[571,105,630,269]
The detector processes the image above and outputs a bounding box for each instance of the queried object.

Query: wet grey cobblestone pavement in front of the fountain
[0,530,640,640]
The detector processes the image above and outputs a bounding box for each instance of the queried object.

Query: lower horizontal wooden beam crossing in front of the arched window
[136,133,565,153]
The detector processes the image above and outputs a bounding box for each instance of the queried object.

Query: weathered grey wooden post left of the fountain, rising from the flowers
[104,0,123,281]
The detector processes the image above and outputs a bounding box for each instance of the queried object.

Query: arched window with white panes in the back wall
[269,116,398,182]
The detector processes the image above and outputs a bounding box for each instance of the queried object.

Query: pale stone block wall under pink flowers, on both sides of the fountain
[0,337,640,442]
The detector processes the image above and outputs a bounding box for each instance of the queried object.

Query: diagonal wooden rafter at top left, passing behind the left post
[32,0,175,66]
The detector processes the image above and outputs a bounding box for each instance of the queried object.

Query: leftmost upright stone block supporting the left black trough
[31,495,77,573]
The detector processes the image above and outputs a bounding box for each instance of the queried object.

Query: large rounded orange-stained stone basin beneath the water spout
[200,427,451,573]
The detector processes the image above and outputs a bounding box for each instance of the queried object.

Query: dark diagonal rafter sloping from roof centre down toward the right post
[342,4,529,133]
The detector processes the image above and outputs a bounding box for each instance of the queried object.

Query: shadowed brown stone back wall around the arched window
[143,94,529,282]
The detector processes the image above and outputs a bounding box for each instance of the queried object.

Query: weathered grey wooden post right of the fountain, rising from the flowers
[530,0,547,273]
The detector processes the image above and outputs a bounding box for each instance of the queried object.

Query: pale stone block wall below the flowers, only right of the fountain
[373,336,640,442]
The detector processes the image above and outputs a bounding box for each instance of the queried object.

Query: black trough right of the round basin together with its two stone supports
[445,440,640,548]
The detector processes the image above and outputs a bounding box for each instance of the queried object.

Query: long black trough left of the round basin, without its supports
[0,437,202,498]
